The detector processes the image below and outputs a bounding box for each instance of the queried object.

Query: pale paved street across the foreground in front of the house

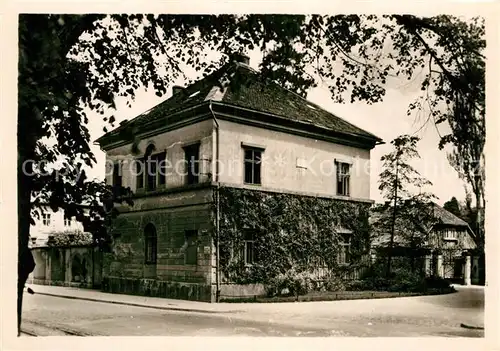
[23,286,484,337]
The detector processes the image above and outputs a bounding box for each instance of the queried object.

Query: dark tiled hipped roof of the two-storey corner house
[100,63,380,144]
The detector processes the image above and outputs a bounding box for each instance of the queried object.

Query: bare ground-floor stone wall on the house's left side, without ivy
[103,188,215,301]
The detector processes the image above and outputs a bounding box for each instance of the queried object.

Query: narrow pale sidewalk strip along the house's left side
[29,284,239,313]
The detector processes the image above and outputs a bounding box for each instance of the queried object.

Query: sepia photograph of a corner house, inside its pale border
[2,4,496,349]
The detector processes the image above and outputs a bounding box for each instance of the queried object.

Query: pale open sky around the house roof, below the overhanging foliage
[88,51,465,205]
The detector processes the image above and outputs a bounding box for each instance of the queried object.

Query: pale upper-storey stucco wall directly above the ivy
[219,121,370,200]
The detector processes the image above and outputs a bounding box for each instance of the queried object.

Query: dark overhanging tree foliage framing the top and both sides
[18,15,484,332]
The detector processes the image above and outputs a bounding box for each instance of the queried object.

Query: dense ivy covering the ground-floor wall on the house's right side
[216,187,370,284]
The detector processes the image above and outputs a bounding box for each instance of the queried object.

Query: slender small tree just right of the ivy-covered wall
[375,135,434,277]
